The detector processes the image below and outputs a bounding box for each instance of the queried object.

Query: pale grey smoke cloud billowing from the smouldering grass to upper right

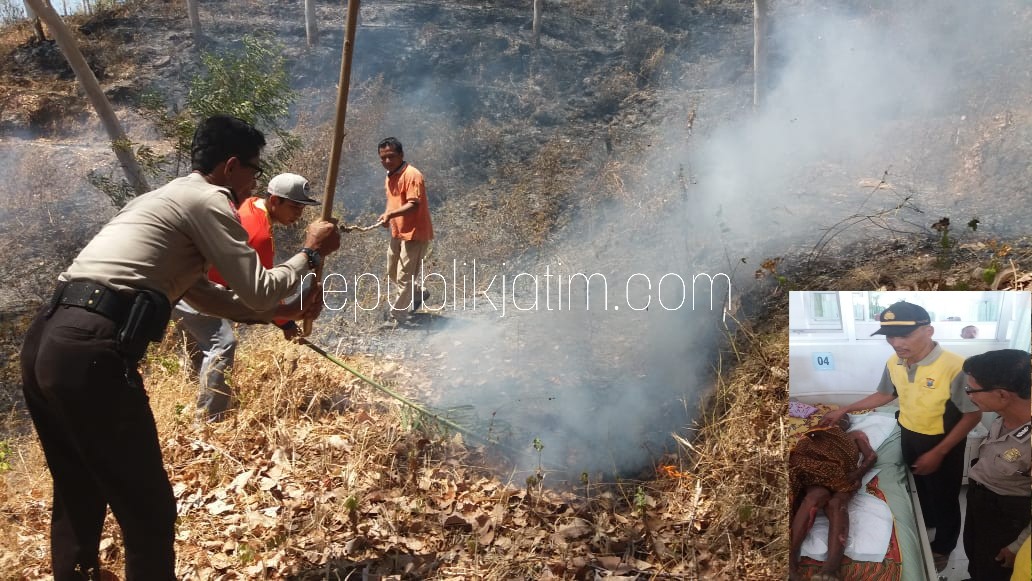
[309,0,1032,482]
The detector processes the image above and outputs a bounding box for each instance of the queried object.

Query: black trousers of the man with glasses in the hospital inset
[964,485,1032,581]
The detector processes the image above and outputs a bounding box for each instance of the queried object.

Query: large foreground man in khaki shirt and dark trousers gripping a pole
[21,116,340,581]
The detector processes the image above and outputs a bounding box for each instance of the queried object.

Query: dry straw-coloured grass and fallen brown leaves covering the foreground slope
[0,307,786,579]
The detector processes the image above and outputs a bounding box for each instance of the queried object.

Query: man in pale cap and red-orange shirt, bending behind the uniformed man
[172,173,320,420]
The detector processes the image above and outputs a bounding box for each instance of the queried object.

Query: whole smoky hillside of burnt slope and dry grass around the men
[0,0,1032,580]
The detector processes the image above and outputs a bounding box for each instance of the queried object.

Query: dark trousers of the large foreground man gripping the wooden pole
[21,306,175,581]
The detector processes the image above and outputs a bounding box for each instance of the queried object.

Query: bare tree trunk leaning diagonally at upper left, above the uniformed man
[25,0,151,195]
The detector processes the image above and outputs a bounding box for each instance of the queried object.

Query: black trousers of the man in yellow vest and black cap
[900,425,965,555]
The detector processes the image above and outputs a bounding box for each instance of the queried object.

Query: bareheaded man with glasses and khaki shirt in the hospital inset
[964,349,1032,581]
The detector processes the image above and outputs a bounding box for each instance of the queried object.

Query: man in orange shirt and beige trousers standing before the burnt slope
[377,137,433,323]
